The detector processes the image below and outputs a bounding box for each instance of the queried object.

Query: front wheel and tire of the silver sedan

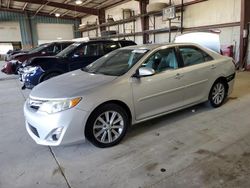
[85,103,129,148]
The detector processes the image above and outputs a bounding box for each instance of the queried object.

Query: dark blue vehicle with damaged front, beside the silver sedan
[20,40,136,89]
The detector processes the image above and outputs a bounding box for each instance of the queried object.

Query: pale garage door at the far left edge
[0,22,21,42]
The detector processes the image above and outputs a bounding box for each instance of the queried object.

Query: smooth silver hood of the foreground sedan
[30,69,117,99]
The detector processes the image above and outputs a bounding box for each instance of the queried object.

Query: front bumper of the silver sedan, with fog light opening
[24,101,89,146]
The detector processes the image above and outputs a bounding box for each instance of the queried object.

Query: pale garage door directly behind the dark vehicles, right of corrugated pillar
[37,23,74,43]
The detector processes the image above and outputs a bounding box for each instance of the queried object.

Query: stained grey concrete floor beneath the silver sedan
[0,60,250,188]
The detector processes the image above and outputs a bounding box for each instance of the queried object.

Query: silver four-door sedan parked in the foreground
[24,43,235,147]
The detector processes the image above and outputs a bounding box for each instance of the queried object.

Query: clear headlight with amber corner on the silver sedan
[39,97,82,114]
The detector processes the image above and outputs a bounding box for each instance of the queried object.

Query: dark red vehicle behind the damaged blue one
[1,41,73,74]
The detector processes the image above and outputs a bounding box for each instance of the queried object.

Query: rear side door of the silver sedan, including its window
[178,46,215,105]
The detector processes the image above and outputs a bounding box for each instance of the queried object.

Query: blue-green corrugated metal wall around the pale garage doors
[0,11,81,48]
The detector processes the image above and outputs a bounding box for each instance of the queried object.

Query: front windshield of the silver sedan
[82,49,148,76]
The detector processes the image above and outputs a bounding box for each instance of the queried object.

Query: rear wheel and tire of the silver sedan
[208,80,227,108]
